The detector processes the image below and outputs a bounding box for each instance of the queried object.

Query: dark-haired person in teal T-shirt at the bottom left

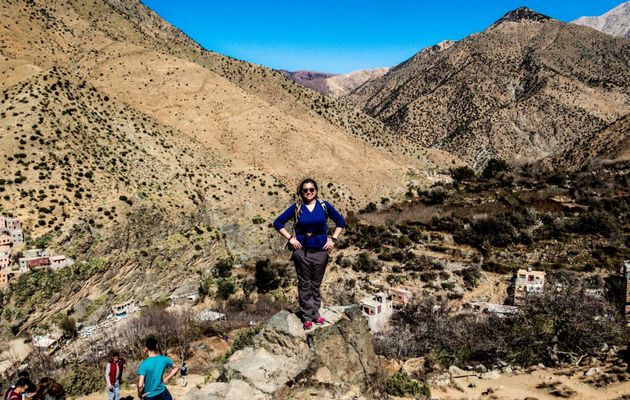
[138,337,179,400]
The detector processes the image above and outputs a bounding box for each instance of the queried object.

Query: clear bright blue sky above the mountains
[142,0,622,73]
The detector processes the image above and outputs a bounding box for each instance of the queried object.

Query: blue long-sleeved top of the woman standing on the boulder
[273,200,346,249]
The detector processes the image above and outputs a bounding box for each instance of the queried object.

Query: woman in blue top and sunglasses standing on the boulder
[273,179,346,329]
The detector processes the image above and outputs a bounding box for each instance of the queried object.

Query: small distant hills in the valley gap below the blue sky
[280,68,389,98]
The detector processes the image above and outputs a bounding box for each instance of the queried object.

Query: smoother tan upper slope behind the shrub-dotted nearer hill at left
[0,0,450,231]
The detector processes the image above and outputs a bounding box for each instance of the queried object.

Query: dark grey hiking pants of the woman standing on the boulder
[291,250,329,322]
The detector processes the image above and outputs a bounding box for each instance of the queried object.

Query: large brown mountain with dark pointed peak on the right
[346,8,630,168]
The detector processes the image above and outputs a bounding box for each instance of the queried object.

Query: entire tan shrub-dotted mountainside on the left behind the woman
[0,0,450,332]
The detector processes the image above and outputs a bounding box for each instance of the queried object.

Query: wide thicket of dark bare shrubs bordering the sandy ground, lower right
[375,276,624,366]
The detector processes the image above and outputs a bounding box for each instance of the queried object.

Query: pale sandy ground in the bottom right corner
[431,370,630,400]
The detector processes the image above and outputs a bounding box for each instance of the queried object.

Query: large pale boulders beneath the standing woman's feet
[188,307,381,400]
